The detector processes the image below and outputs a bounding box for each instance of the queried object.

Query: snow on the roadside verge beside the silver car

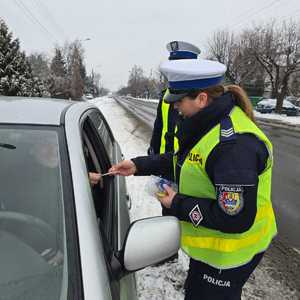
[91,97,297,300]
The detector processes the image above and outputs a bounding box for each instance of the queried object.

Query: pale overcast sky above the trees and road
[0,0,300,90]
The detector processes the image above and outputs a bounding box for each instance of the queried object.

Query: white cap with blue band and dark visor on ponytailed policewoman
[160,59,226,102]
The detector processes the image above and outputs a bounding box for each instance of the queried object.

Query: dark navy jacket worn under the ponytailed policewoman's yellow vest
[133,93,268,233]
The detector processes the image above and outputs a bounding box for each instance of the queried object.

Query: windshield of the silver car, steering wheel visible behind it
[0,127,68,300]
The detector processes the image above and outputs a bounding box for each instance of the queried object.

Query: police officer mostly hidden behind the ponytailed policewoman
[148,41,200,161]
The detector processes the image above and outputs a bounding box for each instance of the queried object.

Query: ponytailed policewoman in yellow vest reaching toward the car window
[112,60,277,300]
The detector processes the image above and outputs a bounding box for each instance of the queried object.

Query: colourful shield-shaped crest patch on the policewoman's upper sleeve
[217,185,244,216]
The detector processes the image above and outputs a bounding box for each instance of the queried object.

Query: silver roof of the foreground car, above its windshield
[0,96,90,125]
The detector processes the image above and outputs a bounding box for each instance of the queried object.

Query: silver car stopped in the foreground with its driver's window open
[0,97,180,300]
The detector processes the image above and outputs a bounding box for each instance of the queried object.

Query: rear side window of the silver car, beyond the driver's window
[89,110,114,161]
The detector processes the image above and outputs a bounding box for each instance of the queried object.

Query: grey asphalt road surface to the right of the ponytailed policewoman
[261,126,300,251]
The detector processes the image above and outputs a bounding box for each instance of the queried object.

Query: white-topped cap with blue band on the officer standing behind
[167,41,201,60]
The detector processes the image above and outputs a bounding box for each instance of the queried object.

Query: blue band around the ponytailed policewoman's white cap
[169,76,223,90]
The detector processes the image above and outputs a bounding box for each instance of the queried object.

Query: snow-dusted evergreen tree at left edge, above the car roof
[0,20,45,96]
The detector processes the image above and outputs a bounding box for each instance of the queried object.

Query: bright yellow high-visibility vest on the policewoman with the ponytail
[174,106,277,269]
